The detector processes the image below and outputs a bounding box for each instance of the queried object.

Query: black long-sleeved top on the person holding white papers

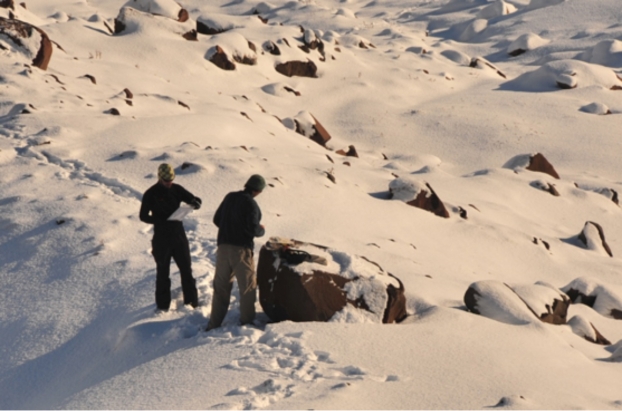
[140,182,197,237]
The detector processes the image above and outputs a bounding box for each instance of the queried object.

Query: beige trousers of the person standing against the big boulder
[207,244,257,330]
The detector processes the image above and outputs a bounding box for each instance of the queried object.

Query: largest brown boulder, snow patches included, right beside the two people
[257,238,407,323]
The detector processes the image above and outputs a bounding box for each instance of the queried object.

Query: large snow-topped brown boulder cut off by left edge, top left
[0,17,52,70]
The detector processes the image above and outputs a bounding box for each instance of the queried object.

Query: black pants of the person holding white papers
[151,229,199,310]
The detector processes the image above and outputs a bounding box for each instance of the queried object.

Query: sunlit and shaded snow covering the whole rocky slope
[0,0,622,409]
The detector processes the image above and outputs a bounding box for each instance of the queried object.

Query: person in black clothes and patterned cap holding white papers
[140,164,201,311]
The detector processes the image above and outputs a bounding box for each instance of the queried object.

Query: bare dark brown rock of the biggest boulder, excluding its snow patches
[257,240,406,323]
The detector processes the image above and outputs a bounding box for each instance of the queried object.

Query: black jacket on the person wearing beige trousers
[214,190,265,250]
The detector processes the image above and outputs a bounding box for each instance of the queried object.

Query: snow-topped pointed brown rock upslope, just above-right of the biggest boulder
[389,177,449,218]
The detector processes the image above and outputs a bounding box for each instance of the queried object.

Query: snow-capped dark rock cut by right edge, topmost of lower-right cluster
[562,277,622,320]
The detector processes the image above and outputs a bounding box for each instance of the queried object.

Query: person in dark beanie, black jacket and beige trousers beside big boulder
[206,174,266,331]
